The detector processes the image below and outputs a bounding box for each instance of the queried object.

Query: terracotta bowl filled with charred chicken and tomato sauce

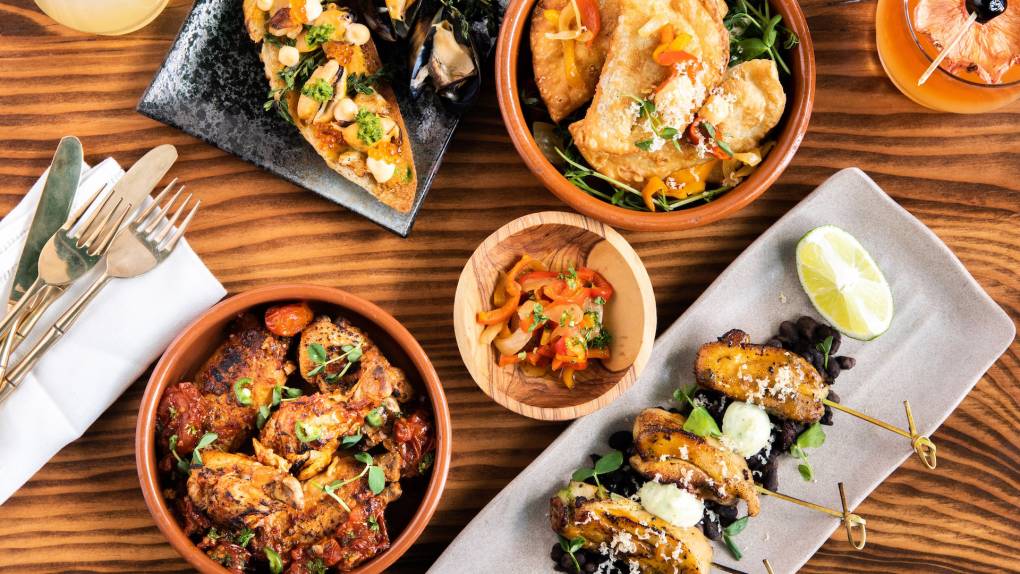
[136,284,451,574]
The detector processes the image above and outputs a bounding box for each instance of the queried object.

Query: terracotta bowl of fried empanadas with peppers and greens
[496,0,815,231]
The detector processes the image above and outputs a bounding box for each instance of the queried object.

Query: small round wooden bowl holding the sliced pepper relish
[453,211,656,420]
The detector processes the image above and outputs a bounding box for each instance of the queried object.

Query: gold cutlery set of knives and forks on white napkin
[0,137,200,404]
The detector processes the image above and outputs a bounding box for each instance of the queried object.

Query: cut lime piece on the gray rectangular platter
[797,225,893,341]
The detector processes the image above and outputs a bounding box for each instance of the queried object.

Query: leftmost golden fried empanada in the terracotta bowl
[530,0,620,123]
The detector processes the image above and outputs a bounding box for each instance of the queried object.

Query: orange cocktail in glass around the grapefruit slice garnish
[875,0,1020,113]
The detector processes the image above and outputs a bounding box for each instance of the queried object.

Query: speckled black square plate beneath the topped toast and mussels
[137,0,485,237]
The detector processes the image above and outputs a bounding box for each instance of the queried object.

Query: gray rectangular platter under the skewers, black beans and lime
[430,168,1016,574]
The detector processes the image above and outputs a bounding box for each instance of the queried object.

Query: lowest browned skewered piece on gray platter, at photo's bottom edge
[549,482,712,574]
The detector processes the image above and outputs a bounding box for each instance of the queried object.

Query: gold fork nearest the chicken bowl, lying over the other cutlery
[0,184,201,404]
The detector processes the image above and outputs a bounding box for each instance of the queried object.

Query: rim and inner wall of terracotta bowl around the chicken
[135,284,452,574]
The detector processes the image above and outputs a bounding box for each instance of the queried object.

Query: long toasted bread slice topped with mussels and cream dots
[243,0,418,212]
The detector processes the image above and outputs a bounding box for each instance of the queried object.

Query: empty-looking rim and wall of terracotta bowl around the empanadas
[496,0,815,231]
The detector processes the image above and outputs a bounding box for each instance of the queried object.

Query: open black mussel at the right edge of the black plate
[410,6,481,105]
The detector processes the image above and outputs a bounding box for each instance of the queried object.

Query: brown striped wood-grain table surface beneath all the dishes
[0,0,1020,572]
